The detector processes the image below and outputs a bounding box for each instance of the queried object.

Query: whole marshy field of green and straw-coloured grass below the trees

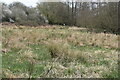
[2,25,119,78]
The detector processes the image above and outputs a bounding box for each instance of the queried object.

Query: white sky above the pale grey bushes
[0,0,39,7]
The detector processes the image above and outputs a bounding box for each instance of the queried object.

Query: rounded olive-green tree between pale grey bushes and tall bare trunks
[37,2,69,24]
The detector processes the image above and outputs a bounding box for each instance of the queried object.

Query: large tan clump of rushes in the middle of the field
[46,40,88,62]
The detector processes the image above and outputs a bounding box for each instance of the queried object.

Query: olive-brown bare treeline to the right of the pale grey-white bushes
[37,0,118,33]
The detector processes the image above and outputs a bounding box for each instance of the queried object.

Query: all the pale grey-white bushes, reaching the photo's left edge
[0,2,48,26]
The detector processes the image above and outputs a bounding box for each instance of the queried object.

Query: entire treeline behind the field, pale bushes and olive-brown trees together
[1,0,119,33]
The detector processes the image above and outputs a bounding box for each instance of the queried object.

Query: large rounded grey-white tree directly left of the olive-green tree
[9,2,47,26]
